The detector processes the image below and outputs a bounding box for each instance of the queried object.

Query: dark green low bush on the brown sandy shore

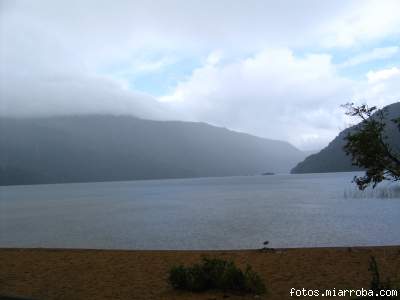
[168,257,266,294]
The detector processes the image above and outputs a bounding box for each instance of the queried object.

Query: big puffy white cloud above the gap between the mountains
[159,49,351,148]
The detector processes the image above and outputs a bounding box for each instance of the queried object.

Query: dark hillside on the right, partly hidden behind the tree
[291,102,400,174]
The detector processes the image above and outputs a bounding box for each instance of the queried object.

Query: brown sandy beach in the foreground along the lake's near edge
[0,246,400,300]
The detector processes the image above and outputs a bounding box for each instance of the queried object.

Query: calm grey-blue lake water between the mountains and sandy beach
[0,173,400,249]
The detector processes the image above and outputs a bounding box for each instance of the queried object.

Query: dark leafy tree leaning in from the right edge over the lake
[344,103,400,190]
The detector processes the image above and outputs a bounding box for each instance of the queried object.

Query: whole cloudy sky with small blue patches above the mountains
[0,0,400,150]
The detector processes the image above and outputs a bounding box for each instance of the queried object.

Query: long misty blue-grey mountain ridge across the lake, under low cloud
[0,115,305,185]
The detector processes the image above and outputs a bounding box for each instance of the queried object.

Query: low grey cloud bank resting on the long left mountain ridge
[0,14,174,119]
